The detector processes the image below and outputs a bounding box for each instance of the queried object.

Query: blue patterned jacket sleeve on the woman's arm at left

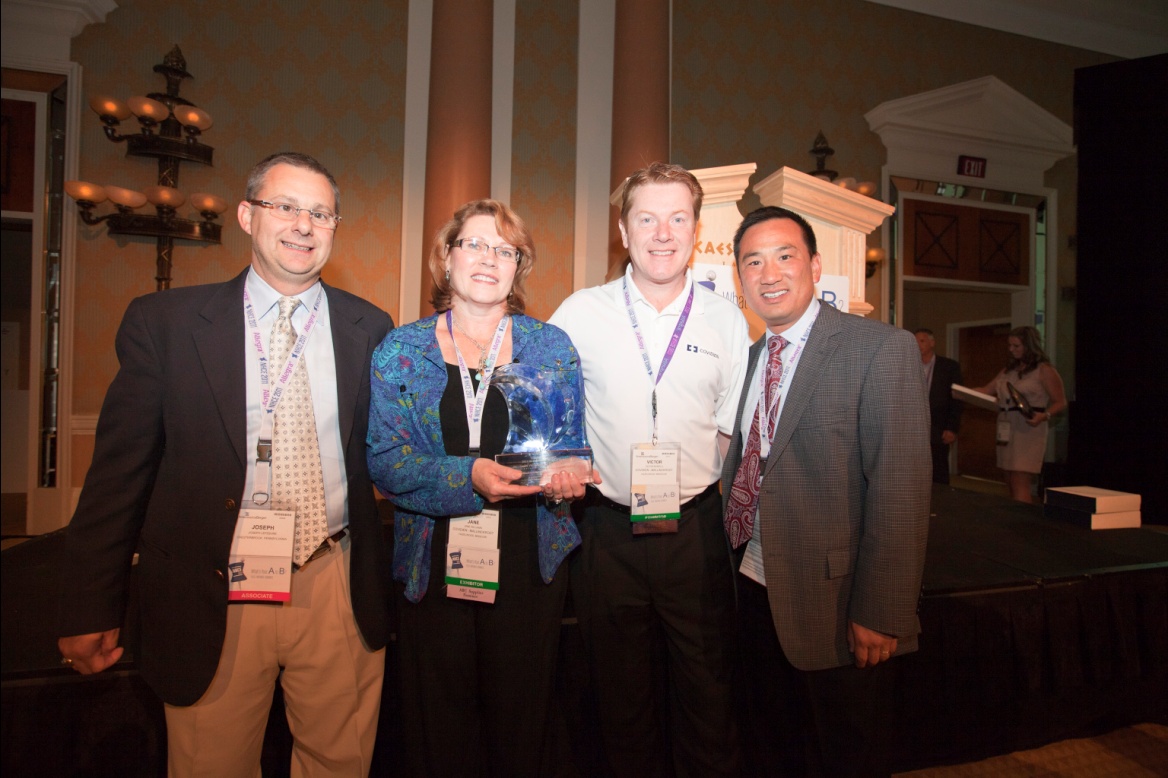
[367,333,484,516]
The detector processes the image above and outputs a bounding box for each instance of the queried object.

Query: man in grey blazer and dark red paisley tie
[722,207,930,774]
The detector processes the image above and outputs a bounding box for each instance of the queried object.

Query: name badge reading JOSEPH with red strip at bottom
[227,507,296,603]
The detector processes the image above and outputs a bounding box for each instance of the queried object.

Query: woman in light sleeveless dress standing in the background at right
[978,327,1066,502]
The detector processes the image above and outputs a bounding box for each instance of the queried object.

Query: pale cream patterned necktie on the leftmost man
[269,297,328,565]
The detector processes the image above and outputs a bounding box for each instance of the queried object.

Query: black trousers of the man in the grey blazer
[735,575,896,777]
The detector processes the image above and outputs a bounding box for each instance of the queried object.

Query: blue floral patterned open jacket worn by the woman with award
[368,314,588,603]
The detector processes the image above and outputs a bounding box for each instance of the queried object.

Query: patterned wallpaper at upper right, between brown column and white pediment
[673,0,1114,211]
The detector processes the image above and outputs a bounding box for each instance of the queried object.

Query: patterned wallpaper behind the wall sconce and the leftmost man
[72,0,408,414]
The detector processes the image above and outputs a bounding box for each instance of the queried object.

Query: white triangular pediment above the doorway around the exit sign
[864,76,1075,192]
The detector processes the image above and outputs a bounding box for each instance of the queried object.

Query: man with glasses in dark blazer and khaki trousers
[58,153,392,776]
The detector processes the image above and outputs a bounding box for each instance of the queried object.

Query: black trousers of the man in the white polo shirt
[572,488,738,778]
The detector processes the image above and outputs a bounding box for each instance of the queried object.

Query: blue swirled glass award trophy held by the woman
[491,363,592,486]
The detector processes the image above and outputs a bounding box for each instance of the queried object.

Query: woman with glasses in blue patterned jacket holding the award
[369,200,585,776]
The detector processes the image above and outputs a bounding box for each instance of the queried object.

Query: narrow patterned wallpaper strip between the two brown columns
[510,0,576,319]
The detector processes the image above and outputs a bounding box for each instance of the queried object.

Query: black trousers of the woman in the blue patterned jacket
[395,510,571,778]
